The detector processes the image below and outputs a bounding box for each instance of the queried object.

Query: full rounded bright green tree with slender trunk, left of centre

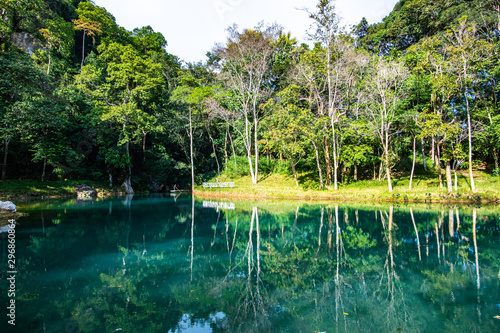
[76,43,165,193]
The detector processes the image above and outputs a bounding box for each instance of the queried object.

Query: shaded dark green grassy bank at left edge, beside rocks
[0,180,120,201]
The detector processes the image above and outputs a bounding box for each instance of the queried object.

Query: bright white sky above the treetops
[94,0,398,62]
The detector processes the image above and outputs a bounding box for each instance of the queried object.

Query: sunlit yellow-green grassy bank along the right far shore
[195,170,500,203]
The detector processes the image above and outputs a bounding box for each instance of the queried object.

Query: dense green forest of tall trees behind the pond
[0,0,500,193]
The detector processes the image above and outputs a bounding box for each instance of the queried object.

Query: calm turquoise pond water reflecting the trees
[0,196,500,333]
